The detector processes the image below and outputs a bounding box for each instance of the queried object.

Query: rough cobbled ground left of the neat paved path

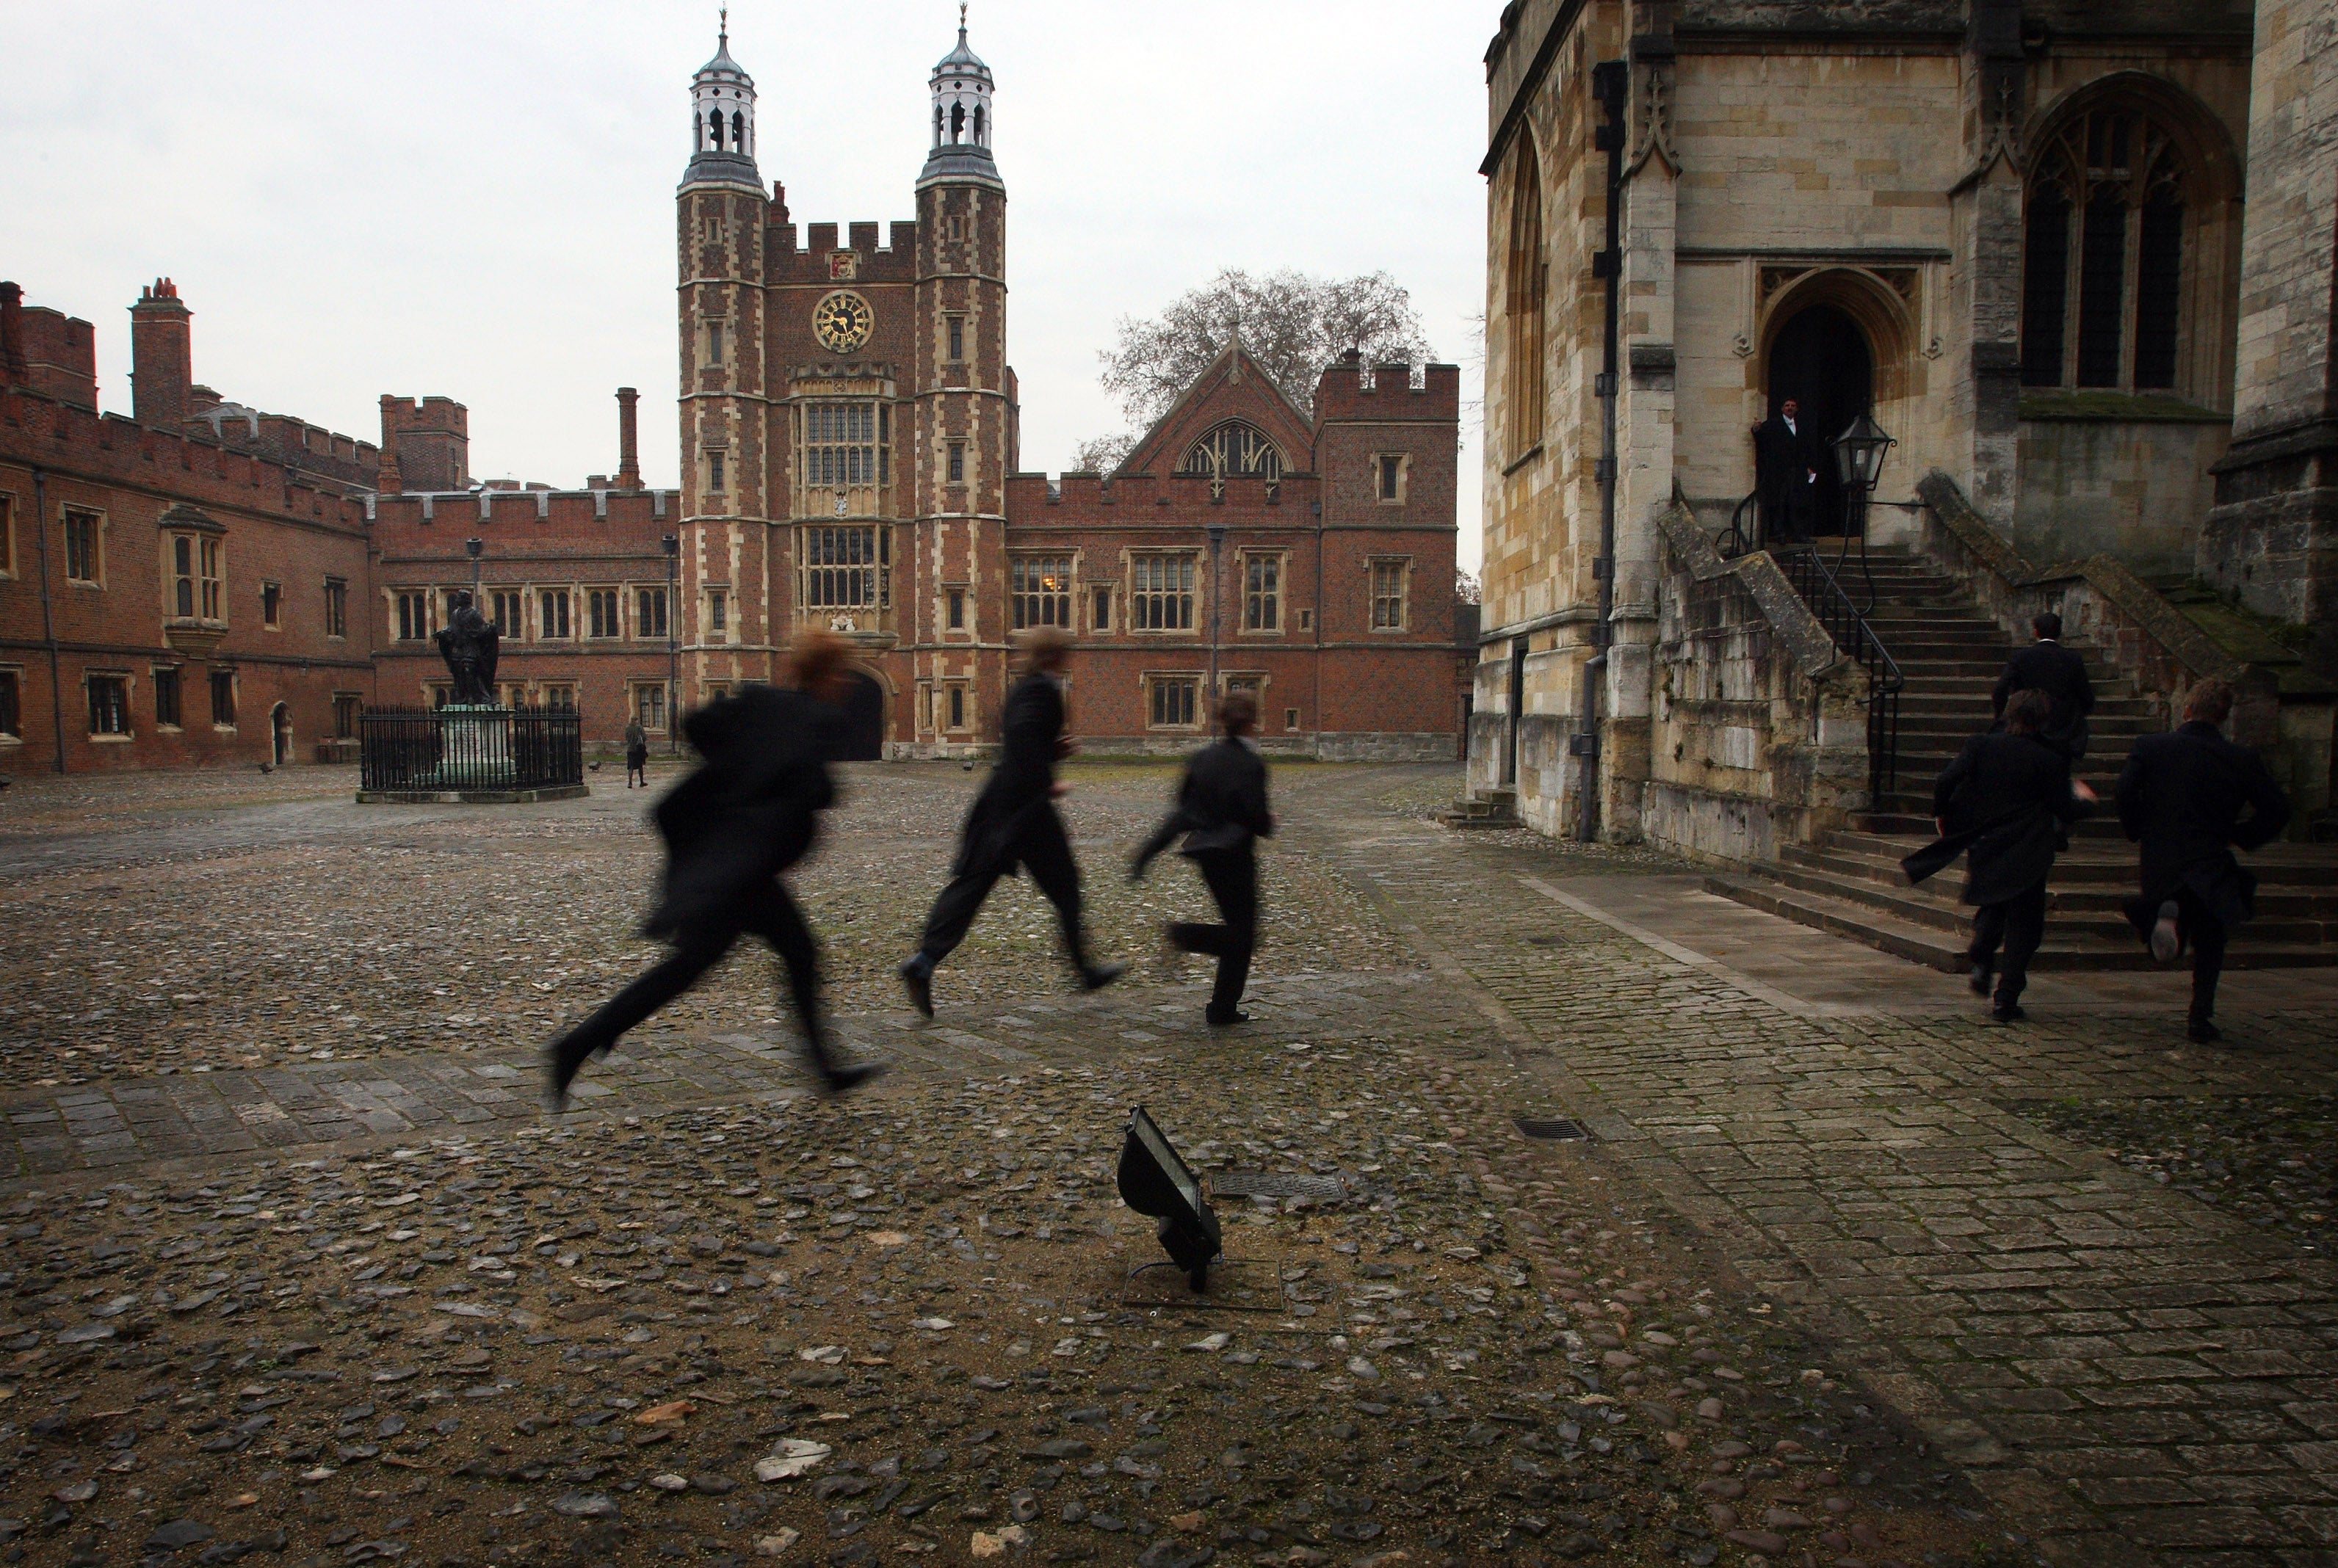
[0,769,2030,1568]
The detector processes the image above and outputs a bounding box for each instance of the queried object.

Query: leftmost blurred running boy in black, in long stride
[545,631,884,1110]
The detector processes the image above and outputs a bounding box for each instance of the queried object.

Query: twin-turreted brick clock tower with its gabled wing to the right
[676,28,1466,757]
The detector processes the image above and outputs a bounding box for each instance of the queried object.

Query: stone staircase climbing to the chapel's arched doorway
[1704,549,2338,972]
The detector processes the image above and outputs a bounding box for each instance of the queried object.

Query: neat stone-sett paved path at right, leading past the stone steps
[1317,780,2338,1564]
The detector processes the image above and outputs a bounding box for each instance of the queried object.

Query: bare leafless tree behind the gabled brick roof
[1076,266,1436,470]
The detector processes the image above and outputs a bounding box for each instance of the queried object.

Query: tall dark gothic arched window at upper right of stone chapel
[2022,105,2188,391]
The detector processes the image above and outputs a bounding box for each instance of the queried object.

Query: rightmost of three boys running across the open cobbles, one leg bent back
[1129,692,1274,1028]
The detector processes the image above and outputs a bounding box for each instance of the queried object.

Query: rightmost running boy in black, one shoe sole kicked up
[2118,680,2289,1045]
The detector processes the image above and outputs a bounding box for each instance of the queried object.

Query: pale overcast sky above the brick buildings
[0,0,1499,565]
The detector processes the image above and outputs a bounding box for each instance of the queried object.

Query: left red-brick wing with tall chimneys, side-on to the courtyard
[0,280,377,771]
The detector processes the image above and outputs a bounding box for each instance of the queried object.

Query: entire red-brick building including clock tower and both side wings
[0,12,1473,769]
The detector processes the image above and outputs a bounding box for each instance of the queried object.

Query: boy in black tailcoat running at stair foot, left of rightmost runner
[1901,692,2095,1023]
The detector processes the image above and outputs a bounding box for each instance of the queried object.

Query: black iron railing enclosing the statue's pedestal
[358,708,584,794]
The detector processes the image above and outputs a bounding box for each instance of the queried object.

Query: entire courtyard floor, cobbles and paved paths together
[0,764,2338,1568]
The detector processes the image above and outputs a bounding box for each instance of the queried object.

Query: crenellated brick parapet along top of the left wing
[0,388,365,528]
